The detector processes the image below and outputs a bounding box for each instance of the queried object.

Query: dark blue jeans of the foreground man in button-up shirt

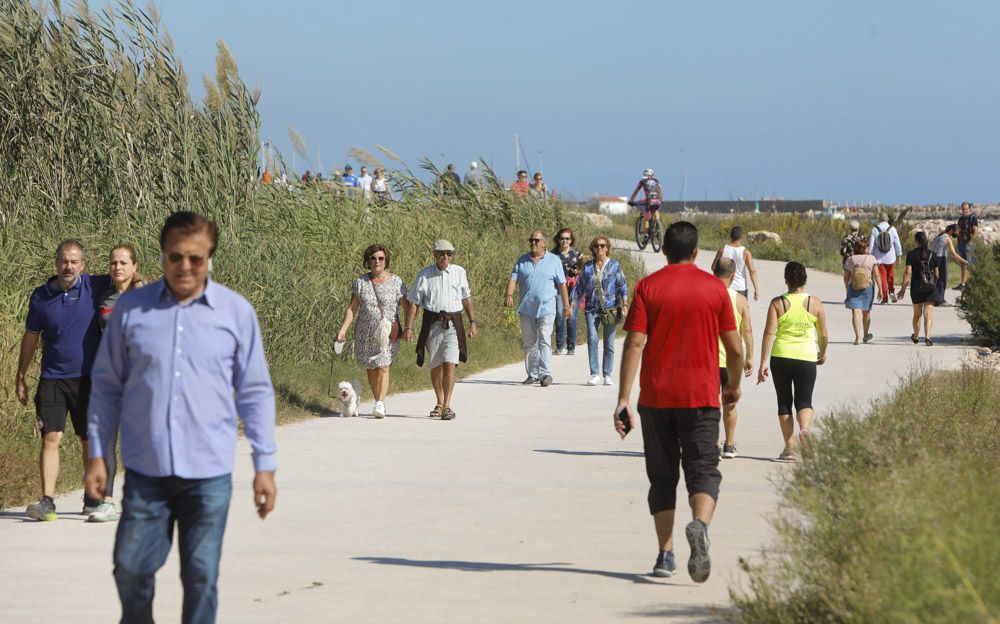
[114,470,233,624]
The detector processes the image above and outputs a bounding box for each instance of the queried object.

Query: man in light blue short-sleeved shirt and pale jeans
[504,230,571,387]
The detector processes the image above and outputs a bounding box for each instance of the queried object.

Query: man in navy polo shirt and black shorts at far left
[17,239,111,520]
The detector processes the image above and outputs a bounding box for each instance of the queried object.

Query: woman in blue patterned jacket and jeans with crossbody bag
[573,236,628,386]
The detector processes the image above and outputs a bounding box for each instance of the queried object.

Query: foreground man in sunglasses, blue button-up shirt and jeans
[84,212,277,622]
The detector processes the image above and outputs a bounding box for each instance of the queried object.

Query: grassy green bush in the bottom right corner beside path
[731,368,1000,624]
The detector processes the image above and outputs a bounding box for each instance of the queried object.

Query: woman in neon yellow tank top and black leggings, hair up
[757,262,830,459]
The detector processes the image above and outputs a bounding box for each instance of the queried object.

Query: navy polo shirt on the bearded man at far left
[24,273,111,379]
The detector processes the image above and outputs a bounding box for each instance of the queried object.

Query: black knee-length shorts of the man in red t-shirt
[639,405,722,514]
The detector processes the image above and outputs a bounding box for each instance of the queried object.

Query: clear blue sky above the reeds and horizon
[160,0,1000,203]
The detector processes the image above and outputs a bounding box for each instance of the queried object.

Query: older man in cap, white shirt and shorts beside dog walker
[403,239,478,420]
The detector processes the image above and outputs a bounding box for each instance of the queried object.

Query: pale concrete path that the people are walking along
[0,247,968,624]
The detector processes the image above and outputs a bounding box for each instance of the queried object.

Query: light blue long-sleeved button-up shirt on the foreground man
[87,280,276,479]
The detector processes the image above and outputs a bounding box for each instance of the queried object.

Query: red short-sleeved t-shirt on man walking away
[625,264,736,408]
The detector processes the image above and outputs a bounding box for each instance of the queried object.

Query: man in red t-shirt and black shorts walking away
[614,221,743,583]
